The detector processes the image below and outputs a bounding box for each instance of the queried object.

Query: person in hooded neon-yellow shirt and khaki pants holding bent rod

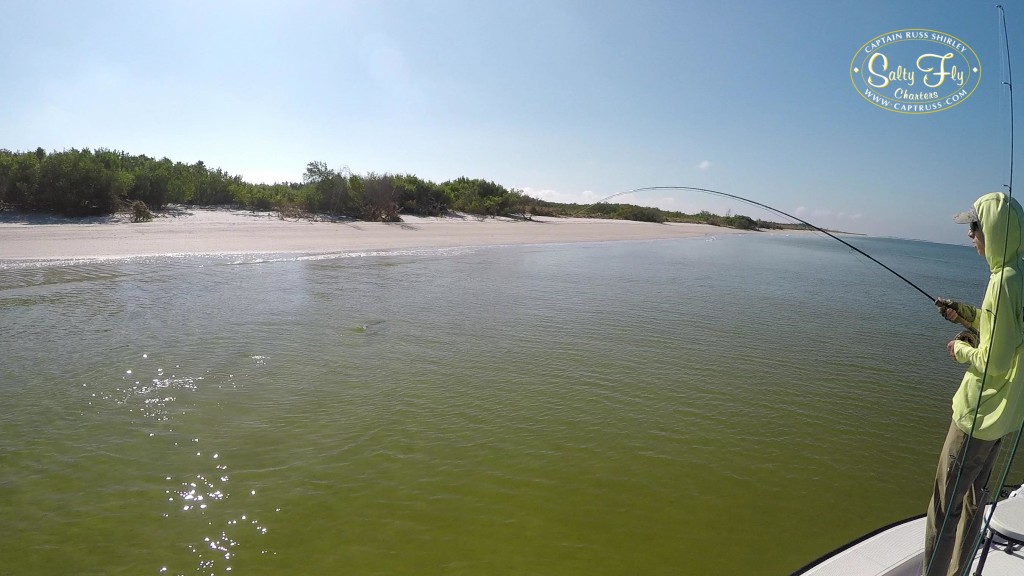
[922,193,1024,576]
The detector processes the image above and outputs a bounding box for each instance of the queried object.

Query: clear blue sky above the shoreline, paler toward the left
[0,0,1024,244]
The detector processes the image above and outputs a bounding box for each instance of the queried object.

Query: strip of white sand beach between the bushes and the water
[0,207,740,259]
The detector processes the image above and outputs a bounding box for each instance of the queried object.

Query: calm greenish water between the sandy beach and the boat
[0,230,1007,576]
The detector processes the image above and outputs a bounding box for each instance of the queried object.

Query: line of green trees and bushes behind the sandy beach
[0,148,794,230]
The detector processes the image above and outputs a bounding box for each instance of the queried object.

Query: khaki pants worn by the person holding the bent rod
[922,416,1000,576]
